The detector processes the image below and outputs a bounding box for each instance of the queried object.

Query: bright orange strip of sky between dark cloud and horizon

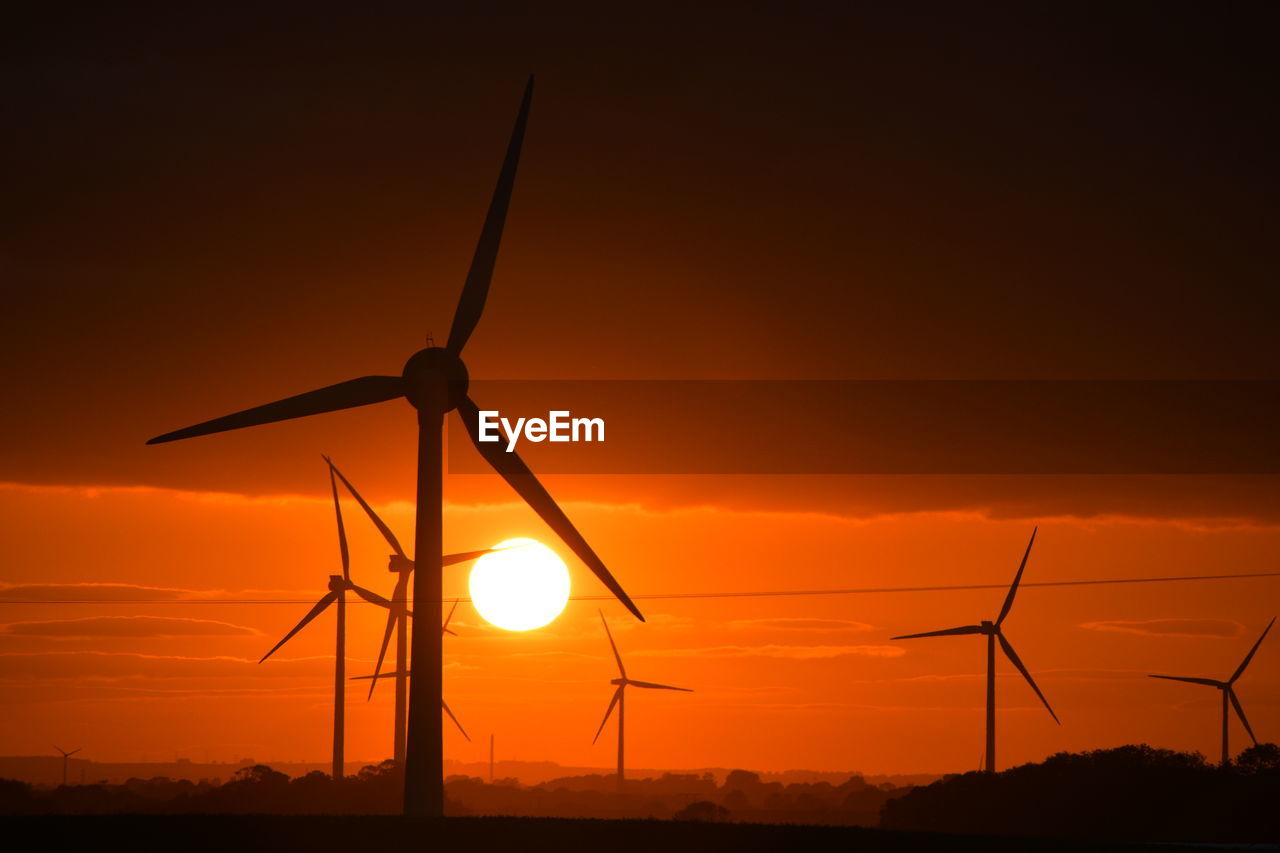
[0,479,1280,772]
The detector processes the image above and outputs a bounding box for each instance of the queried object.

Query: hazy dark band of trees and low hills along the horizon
[0,743,1280,849]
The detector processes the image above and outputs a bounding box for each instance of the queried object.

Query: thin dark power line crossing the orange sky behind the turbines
[0,571,1280,605]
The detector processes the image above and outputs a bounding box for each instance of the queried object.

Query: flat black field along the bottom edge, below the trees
[0,815,1228,853]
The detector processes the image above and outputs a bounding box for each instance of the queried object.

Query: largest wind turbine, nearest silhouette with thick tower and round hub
[147,77,644,817]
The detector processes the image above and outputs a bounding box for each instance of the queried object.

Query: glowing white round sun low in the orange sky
[470,539,568,631]
